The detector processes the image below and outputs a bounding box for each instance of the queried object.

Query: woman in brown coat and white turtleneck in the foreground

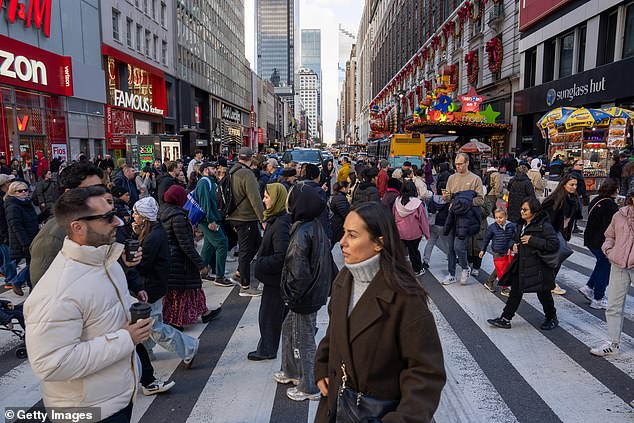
[315,202,446,423]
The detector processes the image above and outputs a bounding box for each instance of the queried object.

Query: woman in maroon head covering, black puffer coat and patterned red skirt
[158,185,220,330]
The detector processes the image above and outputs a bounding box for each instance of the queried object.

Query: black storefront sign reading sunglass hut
[513,57,634,115]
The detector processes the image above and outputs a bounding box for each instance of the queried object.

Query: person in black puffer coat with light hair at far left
[4,182,39,296]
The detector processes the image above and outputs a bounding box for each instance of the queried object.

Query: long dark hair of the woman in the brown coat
[350,201,427,300]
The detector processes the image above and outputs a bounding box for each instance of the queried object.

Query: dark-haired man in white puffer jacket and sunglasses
[24,186,152,421]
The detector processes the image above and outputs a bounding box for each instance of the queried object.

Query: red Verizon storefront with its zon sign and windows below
[0,35,73,164]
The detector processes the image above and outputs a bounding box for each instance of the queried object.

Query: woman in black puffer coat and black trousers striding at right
[488,198,559,330]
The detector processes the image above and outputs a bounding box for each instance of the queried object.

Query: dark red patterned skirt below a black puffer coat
[163,288,208,326]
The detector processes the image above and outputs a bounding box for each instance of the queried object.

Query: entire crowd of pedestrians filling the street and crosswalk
[0,144,634,422]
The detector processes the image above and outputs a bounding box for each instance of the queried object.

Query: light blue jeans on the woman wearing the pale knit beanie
[143,298,199,360]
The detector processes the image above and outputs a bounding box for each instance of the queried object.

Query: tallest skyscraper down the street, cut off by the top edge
[255,0,299,87]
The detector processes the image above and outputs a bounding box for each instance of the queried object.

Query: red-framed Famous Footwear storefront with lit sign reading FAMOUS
[102,45,167,165]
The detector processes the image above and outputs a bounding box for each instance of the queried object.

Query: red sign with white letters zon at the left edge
[0,35,73,96]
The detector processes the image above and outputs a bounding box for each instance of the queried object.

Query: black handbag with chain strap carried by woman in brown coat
[335,363,399,423]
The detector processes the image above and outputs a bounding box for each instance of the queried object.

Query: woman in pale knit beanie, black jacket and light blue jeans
[132,197,198,368]
